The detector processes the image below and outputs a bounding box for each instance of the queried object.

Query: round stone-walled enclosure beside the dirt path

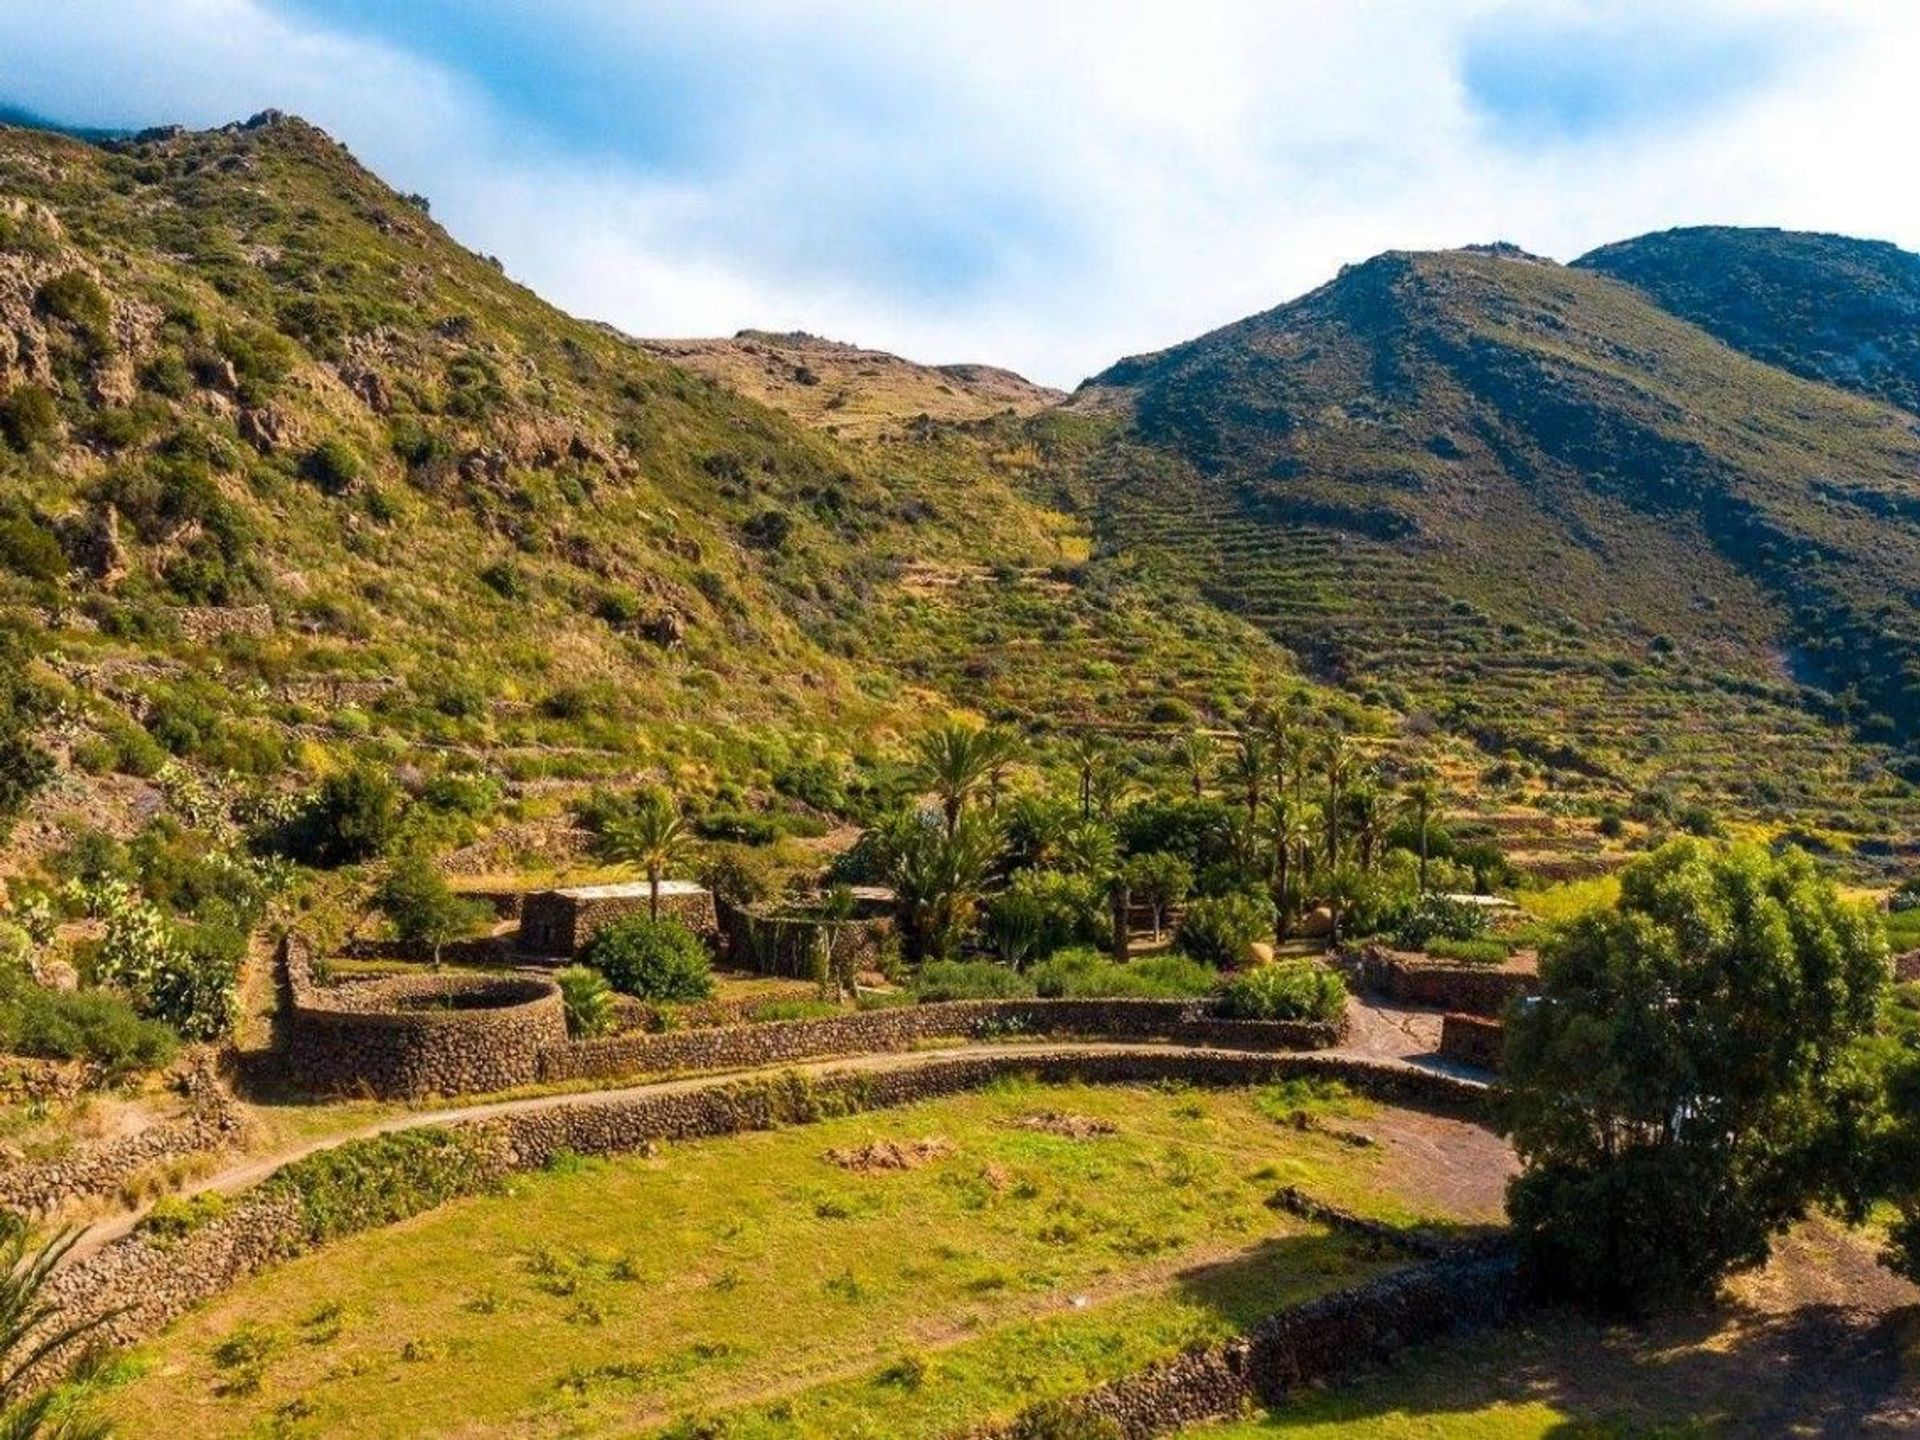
[288,975,566,1098]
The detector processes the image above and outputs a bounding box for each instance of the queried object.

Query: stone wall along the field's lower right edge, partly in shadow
[973,1248,1526,1440]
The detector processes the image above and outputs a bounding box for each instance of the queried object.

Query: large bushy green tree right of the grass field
[1501,841,1887,1309]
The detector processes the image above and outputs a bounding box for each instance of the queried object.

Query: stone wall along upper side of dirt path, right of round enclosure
[540,1000,1340,1081]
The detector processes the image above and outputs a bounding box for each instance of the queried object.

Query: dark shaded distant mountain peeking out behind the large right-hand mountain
[1574,225,1920,413]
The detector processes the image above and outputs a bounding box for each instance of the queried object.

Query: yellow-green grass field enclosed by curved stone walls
[93,1083,1488,1438]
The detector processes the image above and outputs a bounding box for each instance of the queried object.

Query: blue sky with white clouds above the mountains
[0,0,1920,386]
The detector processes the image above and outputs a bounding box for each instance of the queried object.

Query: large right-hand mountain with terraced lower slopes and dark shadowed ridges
[1073,246,1920,852]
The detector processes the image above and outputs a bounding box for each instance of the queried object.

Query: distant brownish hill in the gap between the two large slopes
[636,330,1066,440]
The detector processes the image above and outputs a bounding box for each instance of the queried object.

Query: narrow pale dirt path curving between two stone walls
[56,1000,1475,1263]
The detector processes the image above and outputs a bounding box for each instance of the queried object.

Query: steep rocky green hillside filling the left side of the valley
[0,115,1305,867]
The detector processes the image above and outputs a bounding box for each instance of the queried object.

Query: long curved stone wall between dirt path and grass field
[36,1050,1484,1382]
